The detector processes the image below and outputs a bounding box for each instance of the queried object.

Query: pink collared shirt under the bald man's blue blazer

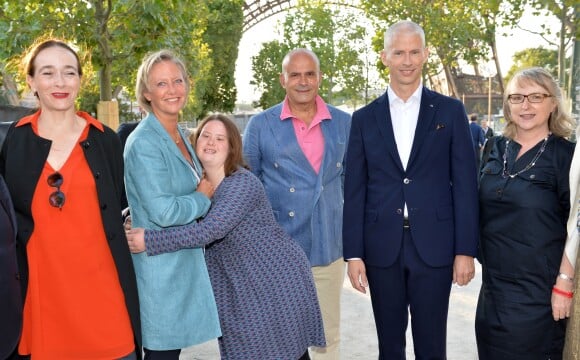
[280,95,331,174]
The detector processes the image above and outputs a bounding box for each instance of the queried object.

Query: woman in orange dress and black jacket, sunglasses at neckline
[0,39,141,360]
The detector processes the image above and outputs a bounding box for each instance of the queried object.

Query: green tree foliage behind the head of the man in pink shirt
[252,1,367,108]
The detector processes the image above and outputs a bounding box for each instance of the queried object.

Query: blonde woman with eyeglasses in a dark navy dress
[475,67,578,360]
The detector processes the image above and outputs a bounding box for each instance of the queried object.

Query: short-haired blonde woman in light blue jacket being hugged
[124,50,221,360]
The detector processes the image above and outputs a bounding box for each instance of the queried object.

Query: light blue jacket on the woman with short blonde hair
[124,114,220,350]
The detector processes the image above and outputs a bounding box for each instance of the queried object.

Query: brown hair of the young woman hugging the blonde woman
[192,114,249,176]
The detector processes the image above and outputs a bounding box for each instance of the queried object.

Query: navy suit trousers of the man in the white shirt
[366,229,453,360]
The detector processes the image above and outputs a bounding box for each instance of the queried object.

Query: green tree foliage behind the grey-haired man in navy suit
[362,0,522,96]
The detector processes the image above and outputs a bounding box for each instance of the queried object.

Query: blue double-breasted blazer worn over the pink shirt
[243,103,350,266]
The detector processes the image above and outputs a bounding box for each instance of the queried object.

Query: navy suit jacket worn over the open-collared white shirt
[343,88,479,267]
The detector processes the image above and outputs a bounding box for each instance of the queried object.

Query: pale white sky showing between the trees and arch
[235,11,557,103]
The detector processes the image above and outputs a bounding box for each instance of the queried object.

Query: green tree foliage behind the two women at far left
[0,0,242,120]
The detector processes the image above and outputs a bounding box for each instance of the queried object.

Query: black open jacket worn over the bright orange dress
[0,118,141,358]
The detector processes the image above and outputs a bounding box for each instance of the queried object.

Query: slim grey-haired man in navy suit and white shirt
[343,21,478,360]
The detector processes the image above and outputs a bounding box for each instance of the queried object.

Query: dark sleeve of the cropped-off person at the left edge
[0,175,22,359]
